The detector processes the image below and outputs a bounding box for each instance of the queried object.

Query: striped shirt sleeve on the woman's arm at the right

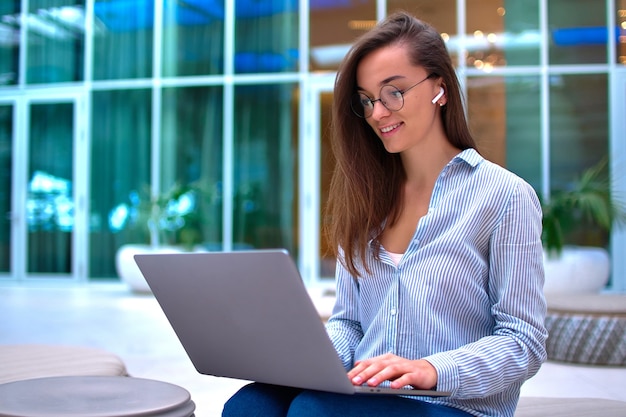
[424,181,547,398]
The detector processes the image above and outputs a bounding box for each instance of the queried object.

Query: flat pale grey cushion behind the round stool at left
[0,344,128,383]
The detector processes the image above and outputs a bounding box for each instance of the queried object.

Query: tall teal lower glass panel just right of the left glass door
[89,90,151,278]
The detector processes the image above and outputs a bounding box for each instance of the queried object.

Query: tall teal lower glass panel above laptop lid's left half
[161,87,223,250]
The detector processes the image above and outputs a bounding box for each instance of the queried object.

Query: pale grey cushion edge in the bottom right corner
[515,397,626,417]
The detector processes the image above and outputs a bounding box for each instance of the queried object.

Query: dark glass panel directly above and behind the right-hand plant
[550,74,609,246]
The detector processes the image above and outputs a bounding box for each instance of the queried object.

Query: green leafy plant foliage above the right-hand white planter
[542,158,626,256]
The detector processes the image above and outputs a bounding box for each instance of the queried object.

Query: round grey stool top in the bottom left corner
[0,376,196,417]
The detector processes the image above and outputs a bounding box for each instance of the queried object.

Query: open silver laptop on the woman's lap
[135,250,449,396]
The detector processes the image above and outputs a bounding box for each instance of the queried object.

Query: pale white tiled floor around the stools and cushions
[0,284,626,417]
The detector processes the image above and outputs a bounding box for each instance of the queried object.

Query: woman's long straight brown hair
[325,12,476,278]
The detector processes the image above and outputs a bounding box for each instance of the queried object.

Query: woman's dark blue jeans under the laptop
[222,383,470,417]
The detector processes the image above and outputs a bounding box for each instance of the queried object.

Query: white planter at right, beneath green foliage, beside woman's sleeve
[543,246,610,294]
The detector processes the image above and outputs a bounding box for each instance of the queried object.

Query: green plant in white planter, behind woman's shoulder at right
[542,158,626,293]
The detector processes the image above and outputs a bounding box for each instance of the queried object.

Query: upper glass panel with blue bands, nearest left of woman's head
[235,0,298,73]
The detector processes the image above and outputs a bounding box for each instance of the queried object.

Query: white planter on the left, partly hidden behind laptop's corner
[115,244,183,293]
